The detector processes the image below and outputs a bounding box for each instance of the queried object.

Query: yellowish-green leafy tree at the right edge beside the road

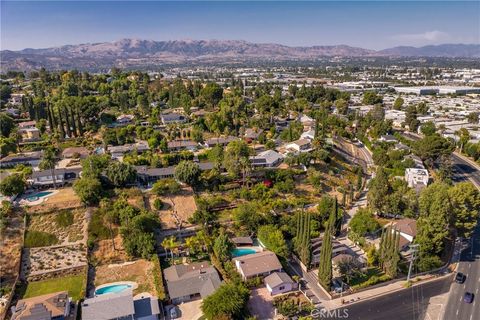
[448,182,480,238]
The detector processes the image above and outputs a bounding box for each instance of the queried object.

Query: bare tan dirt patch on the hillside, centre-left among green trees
[155,189,197,228]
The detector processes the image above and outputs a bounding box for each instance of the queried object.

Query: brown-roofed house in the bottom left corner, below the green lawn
[12,291,71,320]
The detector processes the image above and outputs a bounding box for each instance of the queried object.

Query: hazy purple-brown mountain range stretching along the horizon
[0,39,480,70]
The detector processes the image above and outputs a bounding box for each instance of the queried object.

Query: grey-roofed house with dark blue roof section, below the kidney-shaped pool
[82,290,160,320]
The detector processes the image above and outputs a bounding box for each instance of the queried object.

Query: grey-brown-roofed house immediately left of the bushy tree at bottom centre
[163,261,222,304]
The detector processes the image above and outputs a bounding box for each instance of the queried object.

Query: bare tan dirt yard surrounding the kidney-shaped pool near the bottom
[95,259,156,295]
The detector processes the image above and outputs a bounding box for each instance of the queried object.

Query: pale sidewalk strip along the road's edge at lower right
[322,274,450,310]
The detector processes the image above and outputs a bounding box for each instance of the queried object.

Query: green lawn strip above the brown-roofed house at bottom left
[23,275,85,301]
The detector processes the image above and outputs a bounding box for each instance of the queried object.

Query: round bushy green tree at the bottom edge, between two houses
[201,283,250,320]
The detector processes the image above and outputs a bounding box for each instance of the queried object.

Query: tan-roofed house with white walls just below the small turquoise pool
[232,251,282,280]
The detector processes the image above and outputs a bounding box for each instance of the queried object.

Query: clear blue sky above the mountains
[0,0,480,50]
